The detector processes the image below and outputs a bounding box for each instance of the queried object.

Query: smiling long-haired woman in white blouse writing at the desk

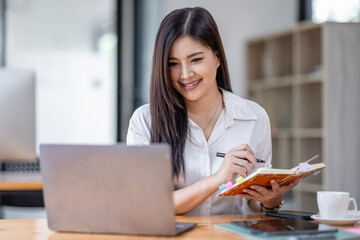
[127,7,299,215]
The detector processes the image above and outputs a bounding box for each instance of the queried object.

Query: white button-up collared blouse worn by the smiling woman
[126,90,272,215]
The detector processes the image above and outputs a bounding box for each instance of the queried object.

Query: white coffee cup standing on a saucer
[317,191,357,219]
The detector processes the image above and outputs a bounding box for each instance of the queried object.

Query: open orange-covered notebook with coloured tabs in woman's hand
[218,163,326,196]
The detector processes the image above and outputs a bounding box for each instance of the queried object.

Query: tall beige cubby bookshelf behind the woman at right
[246,22,360,211]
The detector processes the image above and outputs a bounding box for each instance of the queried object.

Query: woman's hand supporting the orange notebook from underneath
[238,178,302,208]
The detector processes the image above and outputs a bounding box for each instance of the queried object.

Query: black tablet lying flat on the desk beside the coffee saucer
[231,218,337,236]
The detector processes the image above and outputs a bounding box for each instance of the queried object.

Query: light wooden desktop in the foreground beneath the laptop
[0,214,358,240]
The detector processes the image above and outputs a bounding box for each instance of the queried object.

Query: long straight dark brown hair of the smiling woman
[150,7,232,177]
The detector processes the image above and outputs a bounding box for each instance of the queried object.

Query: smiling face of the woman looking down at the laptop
[168,35,220,101]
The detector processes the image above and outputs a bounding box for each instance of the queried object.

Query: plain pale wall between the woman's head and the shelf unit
[161,0,298,96]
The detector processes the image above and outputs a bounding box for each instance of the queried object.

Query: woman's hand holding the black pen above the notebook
[215,144,257,183]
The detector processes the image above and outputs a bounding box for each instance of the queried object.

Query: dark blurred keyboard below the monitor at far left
[0,160,40,173]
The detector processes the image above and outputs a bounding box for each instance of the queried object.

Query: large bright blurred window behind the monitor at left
[5,0,117,150]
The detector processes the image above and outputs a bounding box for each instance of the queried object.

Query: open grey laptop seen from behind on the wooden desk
[40,144,196,236]
